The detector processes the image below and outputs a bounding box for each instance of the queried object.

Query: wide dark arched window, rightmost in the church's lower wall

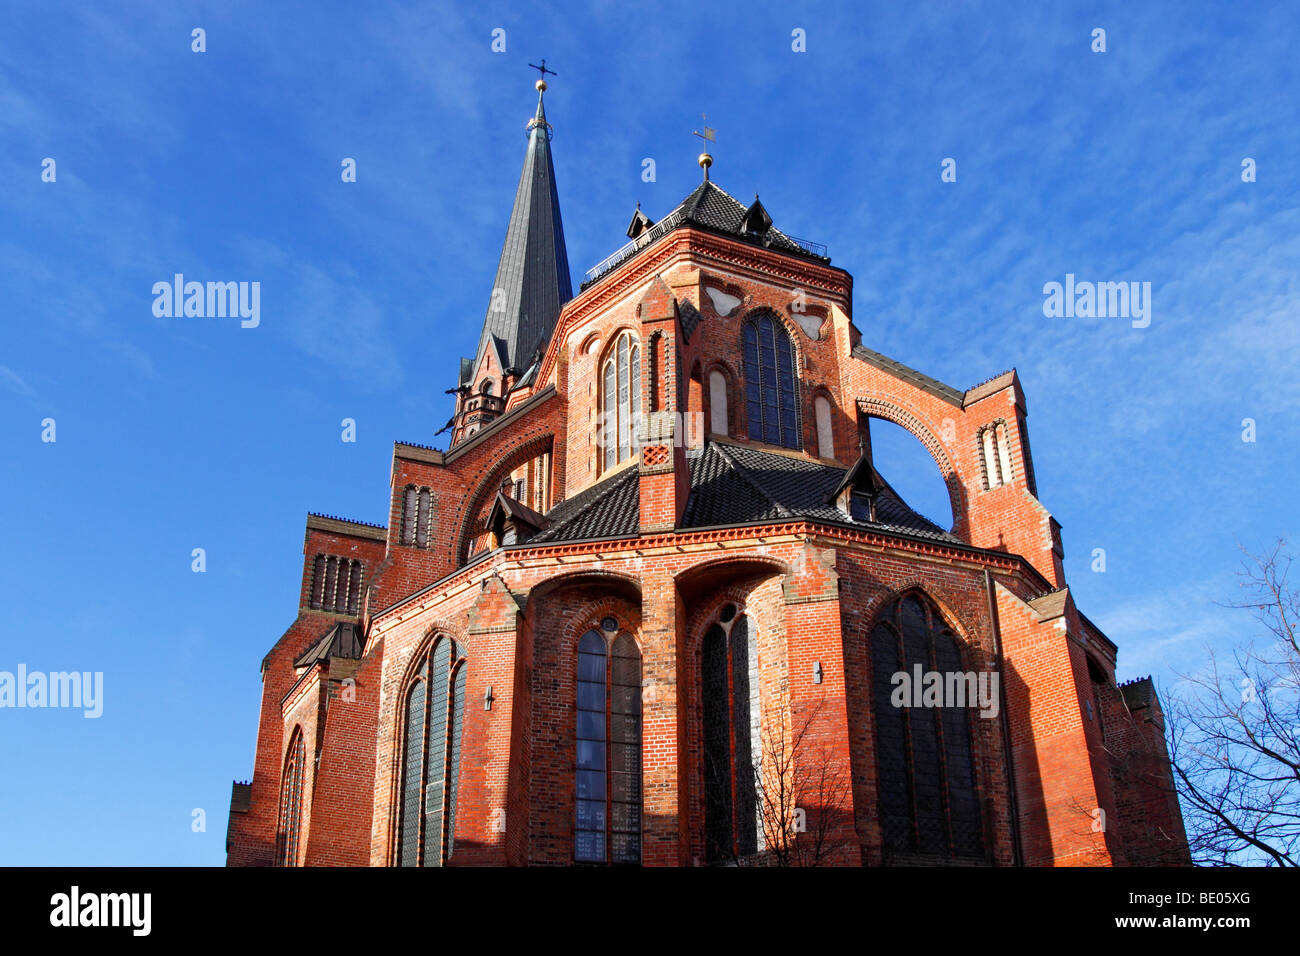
[871,594,984,858]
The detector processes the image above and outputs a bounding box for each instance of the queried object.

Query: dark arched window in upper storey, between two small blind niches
[741,312,803,449]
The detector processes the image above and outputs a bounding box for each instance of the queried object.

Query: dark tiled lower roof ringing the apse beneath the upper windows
[529,441,959,544]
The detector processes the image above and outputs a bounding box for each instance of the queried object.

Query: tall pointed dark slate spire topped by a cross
[475,82,573,369]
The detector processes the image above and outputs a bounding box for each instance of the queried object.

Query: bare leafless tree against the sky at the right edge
[1169,541,1300,866]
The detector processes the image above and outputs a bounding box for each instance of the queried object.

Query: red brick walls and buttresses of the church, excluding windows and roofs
[228,218,1188,866]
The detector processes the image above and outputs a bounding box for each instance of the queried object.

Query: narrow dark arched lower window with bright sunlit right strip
[701,605,759,862]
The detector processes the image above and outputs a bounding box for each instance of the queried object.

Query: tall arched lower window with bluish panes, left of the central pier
[573,618,641,865]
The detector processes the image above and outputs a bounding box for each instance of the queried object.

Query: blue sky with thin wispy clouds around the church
[0,0,1300,865]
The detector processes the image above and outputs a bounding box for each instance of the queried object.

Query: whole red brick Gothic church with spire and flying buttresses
[226,81,1188,866]
